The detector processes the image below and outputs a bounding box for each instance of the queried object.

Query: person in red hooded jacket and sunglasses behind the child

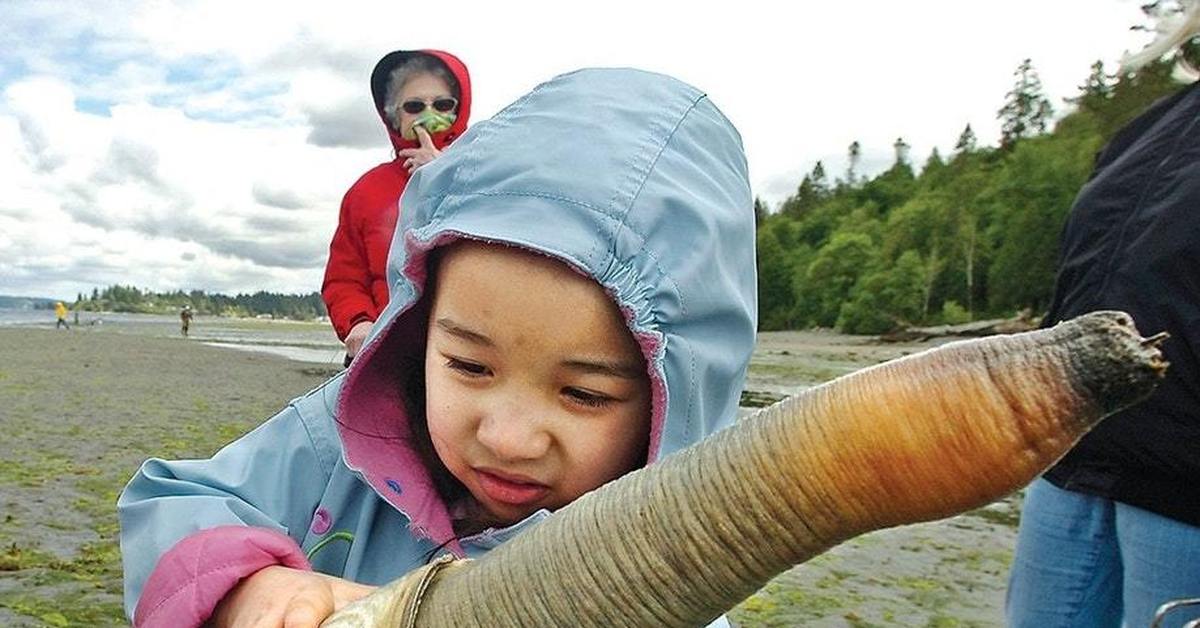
[320,50,470,365]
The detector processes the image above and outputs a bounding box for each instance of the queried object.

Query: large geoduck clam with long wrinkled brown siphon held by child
[325,312,1166,627]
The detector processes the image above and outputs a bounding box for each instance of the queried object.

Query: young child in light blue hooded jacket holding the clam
[118,70,756,626]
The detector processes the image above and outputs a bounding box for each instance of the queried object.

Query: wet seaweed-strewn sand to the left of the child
[0,328,335,627]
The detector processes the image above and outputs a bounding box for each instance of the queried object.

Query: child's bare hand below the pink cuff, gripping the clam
[209,566,376,628]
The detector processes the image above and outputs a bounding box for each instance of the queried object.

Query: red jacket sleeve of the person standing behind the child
[320,186,374,340]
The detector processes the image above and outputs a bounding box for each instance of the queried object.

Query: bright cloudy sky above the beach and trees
[0,0,1148,299]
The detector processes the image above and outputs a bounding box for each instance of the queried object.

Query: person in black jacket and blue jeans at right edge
[1006,12,1200,628]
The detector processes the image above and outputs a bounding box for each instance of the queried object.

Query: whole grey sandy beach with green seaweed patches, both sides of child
[0,323,1019,627]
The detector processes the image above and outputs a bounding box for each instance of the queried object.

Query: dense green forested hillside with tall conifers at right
[755,55,1180,334]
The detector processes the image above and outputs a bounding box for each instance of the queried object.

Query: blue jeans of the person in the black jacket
[1004,478,1200,628]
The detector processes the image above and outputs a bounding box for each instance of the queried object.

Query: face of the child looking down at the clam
[425,243,650,525]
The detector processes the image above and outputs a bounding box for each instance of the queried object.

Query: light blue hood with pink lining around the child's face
[337,65,757,540]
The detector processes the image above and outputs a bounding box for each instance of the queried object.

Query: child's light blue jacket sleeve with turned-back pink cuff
[118,406,332,627]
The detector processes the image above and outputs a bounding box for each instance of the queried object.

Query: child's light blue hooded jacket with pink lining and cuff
[119,70,757,626]
